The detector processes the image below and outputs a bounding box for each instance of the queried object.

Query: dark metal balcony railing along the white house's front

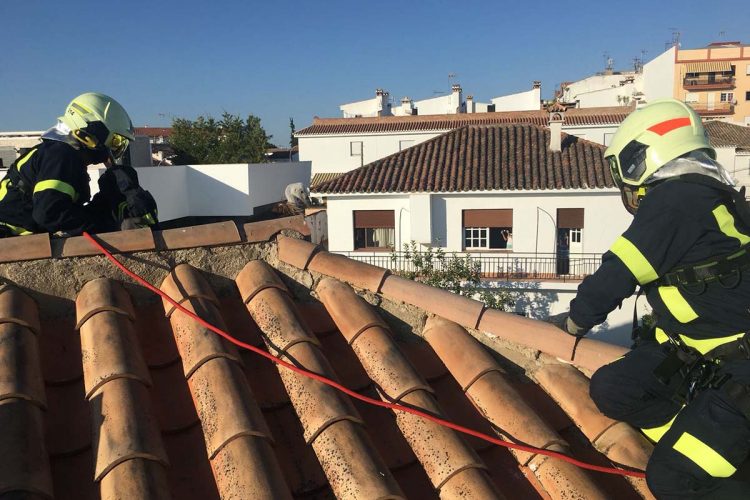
[335,251,602,282]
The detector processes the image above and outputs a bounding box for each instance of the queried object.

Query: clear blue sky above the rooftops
[0,0,750,145]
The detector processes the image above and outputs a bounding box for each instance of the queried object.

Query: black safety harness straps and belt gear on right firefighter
[633,174,750,419]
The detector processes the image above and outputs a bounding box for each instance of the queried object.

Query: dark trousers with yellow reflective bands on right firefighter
[590,341,750,499]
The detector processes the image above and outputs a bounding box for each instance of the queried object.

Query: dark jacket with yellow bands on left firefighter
[0,140,117,235]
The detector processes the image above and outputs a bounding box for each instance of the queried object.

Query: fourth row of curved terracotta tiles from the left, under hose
[237,261,408,498]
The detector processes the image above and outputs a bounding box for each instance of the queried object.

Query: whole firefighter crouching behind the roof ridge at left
[0,93,157,237]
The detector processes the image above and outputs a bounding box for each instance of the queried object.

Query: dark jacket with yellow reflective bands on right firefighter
[570,179,750,346]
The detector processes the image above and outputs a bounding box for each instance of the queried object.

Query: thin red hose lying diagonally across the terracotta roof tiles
[83,232,646,478]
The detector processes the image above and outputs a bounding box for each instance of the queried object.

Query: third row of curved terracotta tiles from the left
[161,264,291,499]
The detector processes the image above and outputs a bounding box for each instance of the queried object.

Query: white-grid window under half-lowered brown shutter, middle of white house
[462,208,513,250]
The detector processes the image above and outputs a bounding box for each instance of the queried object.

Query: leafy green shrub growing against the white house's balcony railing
[391,241,516,311]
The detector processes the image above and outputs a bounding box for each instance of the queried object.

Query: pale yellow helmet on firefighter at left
[59,92,135,158]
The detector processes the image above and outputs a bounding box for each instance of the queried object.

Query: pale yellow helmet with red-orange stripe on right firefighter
[604,99,716,213]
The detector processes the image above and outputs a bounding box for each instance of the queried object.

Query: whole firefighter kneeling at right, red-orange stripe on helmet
[556,99,750,499]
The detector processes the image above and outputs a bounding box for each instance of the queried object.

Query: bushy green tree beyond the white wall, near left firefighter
[169,112,272,165]
